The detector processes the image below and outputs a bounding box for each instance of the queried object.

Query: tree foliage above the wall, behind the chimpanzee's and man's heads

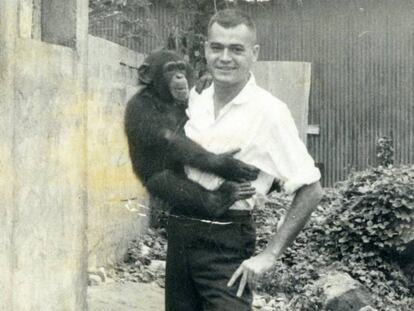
[89,0,254,76]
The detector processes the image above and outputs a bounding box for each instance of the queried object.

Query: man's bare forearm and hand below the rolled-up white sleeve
[228,182,323,297]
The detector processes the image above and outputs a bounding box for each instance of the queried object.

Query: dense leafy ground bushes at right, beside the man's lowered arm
[257,166,414,311]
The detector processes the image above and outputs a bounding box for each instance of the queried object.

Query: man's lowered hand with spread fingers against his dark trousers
[227,252,276,297]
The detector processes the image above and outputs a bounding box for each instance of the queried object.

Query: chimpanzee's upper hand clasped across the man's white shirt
[215,148,259,182]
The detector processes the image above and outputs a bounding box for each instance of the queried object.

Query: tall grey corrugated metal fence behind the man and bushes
[92,0,414,185]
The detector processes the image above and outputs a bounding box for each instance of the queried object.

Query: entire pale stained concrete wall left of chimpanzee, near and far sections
[0,0,149,311]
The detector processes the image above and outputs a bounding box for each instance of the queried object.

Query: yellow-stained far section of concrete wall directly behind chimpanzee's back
[87,36,147,269]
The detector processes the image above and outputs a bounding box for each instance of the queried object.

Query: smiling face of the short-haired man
[205,23,259,86]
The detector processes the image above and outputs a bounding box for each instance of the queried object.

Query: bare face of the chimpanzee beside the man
[163,61,190,101]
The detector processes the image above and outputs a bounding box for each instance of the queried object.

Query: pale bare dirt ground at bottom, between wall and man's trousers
[88,282,164,311]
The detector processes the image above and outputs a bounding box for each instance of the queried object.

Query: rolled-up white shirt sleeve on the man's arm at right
[257,103,321,193]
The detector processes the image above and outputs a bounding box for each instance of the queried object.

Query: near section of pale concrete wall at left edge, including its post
[0,1,87,311]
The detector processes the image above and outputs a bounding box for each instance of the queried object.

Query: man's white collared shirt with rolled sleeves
[184,74,321,209]
